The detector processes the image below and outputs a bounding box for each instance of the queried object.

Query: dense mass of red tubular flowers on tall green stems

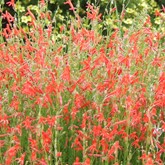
[0,0,165,165]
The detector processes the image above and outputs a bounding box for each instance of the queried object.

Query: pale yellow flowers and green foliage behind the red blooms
[9,0,164,34]
